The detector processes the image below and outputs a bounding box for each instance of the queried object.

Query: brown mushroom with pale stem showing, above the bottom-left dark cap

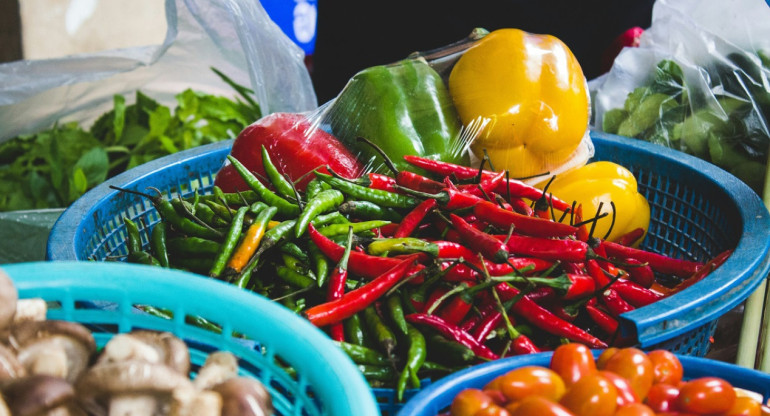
[9,320,96,382]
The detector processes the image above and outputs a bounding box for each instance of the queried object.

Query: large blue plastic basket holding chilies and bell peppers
[47,133,770,414]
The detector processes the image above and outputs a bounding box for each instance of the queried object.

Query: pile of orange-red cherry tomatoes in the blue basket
[447,343,770,416]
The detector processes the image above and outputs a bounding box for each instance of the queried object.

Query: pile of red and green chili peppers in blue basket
[111,144,731,398]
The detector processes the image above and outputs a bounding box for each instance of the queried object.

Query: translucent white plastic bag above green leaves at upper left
[0,0,317,141]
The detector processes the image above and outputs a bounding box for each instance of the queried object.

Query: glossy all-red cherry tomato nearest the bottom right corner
[677,377,735,413]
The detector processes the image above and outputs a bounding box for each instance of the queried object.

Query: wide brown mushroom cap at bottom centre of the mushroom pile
[75,360,192,414]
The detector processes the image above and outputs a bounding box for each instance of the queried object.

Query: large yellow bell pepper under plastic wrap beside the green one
[449,29,590,177]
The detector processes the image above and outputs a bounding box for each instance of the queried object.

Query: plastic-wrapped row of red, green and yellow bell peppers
[217,29,593,192]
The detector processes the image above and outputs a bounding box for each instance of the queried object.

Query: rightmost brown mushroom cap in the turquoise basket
[211,377,273,416]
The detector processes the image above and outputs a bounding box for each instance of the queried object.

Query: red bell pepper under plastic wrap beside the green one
[214,113,364,192]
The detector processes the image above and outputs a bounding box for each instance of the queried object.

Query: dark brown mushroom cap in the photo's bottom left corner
[3,374,75,416]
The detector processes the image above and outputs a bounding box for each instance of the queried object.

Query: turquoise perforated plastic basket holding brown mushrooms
[2,262,378,416]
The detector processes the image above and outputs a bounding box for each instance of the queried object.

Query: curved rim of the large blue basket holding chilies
[47,132,770,348]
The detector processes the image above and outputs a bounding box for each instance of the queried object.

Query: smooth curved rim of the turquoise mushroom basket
[0,261,378,416]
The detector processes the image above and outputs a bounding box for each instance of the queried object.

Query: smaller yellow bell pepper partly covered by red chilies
[538,161,650,242]
